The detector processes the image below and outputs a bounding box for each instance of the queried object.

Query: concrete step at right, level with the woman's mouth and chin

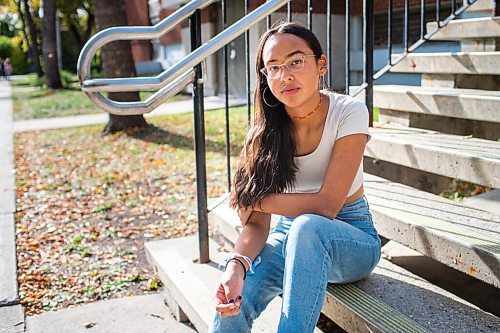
[373,85,500,122]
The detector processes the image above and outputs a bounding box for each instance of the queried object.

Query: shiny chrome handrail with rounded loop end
[78,0,290,115]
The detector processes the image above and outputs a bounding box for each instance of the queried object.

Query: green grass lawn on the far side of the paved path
[12,74,190,121]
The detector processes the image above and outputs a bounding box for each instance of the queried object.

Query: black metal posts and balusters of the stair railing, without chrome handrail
[193,0,476,262]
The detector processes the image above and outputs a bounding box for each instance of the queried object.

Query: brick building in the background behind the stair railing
[126,0,453,96]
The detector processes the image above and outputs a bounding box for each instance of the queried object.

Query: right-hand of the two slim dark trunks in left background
[42,0,62,89]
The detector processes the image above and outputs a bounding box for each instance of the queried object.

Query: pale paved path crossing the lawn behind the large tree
[14,96,246,132]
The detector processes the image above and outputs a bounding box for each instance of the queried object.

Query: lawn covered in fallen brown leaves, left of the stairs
[15,108,246,315]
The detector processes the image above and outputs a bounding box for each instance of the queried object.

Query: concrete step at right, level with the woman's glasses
[391,52,500,75]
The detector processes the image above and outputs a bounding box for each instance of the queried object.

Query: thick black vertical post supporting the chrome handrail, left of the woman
[190,9,210,263]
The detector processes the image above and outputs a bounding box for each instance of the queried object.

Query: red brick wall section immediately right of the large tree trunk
[125,0,152,62]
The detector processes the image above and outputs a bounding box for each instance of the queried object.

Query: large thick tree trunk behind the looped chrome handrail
[94,0,149,135]
